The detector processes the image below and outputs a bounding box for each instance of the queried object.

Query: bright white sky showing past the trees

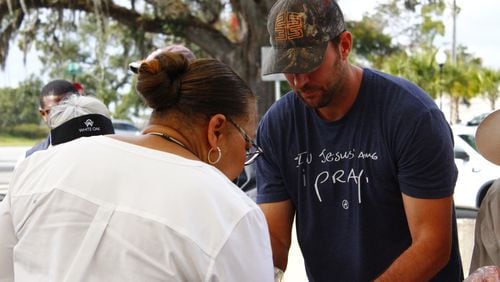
[0,0,500,87]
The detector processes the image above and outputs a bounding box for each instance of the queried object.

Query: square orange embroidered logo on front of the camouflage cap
[274,12,304,41]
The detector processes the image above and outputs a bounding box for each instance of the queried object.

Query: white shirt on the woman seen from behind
[0,136,274,282]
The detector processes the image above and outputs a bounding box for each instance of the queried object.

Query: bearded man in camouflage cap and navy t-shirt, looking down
[256,0,463,281]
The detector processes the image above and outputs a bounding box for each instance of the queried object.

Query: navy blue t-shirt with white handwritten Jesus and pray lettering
[257,69,463,281]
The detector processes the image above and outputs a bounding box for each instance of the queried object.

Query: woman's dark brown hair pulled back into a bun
[136,52,255,118]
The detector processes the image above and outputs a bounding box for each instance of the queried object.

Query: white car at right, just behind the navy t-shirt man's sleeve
[452,125,500,208]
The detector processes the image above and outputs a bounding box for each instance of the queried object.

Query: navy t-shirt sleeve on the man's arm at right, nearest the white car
[396,109,458,199]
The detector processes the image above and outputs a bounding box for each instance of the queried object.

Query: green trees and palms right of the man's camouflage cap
[352,0,500,117]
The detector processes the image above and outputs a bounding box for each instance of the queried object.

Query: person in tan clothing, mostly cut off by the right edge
[470,110,500,274]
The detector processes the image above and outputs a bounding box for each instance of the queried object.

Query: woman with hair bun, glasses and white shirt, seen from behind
[0,51,274,281]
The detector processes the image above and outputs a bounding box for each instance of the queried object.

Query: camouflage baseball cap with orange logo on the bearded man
[262,0,345,75]
